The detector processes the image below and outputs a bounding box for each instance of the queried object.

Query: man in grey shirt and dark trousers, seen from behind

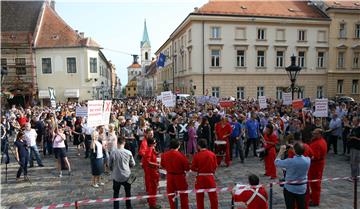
[109,137,135,209]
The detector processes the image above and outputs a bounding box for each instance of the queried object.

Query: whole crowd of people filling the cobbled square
[1,98,360,209]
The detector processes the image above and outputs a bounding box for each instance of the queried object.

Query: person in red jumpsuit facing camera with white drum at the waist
[215,117,232,167]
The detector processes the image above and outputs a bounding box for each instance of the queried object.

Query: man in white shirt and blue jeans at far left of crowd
[24,123,44,168]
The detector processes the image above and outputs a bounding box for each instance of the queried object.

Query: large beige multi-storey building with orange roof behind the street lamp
[156,1,358,99]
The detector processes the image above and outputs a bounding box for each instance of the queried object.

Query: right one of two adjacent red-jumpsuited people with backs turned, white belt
[191,139,218,209]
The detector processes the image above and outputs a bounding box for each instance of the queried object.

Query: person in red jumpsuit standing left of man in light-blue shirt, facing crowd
[264,123,278,179]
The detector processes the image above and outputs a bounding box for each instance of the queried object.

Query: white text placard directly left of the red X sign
[87,100,104,127]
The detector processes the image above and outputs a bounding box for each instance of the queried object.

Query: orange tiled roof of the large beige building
[195,0,327,18]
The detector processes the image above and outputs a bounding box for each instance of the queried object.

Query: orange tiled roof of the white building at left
[35,4,100,48]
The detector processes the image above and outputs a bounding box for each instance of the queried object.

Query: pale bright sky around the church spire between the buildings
[55,0,207,86]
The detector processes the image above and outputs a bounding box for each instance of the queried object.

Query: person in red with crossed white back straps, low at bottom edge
[233,174,268,209]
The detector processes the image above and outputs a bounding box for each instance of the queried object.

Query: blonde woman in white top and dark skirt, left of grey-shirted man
[90,131,104,188]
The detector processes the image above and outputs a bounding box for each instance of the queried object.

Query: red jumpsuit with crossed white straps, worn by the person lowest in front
[234,187,268,209]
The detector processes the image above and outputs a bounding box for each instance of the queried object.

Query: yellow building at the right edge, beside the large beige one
[316,1,360,101]
